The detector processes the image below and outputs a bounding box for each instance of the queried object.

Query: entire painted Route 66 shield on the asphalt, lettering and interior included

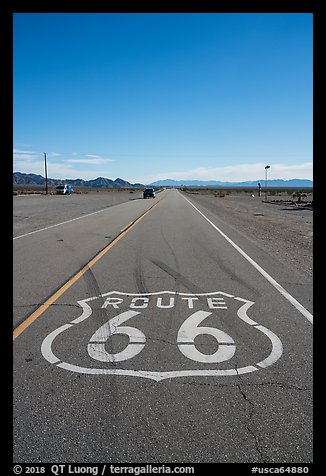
[41,291,283,381]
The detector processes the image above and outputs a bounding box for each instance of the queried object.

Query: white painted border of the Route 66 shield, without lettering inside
[41,291,283,382]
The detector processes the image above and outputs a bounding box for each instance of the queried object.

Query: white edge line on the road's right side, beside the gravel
[181,195,313,324]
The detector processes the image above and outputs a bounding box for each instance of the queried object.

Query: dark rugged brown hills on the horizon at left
[13,172,144,188]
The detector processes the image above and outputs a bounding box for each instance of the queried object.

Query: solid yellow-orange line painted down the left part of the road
[13,199,162,340]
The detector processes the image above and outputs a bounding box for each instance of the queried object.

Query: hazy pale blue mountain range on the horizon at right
[148,179,313,188]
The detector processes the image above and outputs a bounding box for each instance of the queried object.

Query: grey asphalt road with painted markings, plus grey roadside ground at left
[13,190,313,463]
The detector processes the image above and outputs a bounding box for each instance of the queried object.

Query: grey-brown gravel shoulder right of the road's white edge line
[183,191,313,279]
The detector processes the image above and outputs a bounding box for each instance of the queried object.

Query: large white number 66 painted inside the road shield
[87,310,236,363]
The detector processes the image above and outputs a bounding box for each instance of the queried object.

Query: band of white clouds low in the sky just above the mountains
[13,144,313,183]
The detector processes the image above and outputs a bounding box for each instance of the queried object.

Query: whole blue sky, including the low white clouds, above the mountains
[13,13,313,183]
